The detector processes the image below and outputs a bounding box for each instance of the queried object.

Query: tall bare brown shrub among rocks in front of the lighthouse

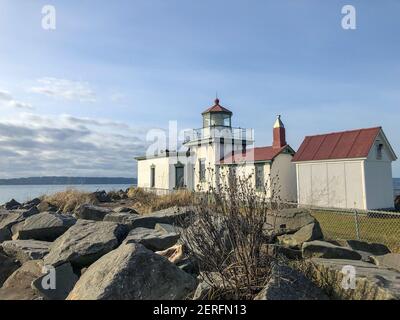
[182,172,275,299]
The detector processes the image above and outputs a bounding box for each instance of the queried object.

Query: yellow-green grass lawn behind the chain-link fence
[312,211,400,253]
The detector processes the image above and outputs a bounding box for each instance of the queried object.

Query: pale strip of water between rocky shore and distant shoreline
[0,184,131,204]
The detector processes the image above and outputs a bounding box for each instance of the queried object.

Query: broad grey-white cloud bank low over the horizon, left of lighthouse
[0,113,147,178]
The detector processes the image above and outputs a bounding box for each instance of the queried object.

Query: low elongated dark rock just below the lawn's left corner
[302,240,361,260]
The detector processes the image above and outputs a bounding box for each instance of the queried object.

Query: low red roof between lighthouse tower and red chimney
[221,145,288,164]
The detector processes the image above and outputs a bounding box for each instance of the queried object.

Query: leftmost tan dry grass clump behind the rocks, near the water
[43,189,97,213]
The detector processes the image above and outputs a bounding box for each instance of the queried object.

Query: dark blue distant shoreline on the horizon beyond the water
[0,177,137,186]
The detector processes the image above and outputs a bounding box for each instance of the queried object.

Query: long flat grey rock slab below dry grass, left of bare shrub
[132,207,193,229]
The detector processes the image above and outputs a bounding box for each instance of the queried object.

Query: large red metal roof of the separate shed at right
[292,127,381,161]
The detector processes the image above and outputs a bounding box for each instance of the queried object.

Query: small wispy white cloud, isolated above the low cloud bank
[29,77,96,102]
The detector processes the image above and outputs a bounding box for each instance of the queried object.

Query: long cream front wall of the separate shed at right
[296,160,366,209]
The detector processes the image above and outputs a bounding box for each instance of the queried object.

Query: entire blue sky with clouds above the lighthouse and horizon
[0,0,400,178]
